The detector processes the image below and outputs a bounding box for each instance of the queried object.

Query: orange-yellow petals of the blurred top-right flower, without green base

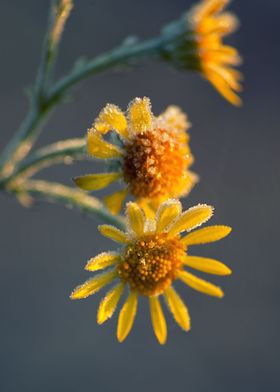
[190,0,242,105]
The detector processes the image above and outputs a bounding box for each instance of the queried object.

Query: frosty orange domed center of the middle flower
[123,129,192,198]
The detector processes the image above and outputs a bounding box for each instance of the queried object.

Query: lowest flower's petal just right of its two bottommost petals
[164,287,191,331]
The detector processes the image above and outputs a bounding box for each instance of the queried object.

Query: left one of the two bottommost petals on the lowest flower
[117,291,138,342]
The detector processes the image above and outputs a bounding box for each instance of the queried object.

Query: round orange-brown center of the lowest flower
[117,233,185,296]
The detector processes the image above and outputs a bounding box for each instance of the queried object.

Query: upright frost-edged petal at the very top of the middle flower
[128,97,153,133]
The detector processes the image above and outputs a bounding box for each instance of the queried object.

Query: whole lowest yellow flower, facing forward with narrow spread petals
[71,199,231,344]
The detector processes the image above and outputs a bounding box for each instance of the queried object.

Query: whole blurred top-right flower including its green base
[163,0,242,106]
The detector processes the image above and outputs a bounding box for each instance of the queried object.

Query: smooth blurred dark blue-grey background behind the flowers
[0,0,280,392]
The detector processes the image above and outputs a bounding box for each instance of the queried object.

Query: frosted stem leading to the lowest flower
[15,180,125,230]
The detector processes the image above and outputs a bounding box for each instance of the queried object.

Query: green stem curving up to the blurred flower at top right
[0,37,162,177]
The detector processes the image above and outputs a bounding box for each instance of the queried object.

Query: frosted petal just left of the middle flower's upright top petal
[94,104,127,138]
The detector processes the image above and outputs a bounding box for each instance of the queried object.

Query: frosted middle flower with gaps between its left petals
[74,97,198,213]
